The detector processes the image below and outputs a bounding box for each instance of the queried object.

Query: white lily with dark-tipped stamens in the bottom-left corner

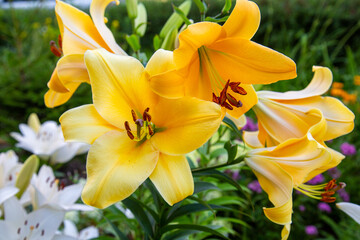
[0,197,64,240]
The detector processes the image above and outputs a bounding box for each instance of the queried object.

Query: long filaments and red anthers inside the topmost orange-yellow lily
[198,46,247,110]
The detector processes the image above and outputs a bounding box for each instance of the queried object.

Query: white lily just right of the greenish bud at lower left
[31,165,94,211]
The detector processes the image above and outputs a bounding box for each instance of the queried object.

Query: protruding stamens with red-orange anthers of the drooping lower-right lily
[295,179,346,203]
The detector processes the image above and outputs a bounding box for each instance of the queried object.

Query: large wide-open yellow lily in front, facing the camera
[60,49,225,208]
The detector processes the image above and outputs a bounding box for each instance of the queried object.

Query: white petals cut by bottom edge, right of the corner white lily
[53,220,99,240]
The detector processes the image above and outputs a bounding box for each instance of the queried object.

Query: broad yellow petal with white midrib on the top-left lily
[55,0,110,55]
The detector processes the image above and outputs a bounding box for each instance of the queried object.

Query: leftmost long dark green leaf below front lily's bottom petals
[122,196,154,237]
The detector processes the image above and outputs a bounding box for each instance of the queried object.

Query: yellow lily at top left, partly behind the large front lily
[44,0,127,108]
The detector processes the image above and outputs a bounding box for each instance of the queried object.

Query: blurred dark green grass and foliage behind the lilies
[0,0,360,239]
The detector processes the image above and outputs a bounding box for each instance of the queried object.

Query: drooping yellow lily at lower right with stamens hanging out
[245,110,344,240]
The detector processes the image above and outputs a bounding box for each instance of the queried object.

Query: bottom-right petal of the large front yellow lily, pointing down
[150,153,194,206]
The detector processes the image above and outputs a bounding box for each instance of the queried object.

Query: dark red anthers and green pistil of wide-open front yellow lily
[124,108,155,141]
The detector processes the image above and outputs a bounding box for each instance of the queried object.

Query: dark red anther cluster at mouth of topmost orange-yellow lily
[213,79,247,110]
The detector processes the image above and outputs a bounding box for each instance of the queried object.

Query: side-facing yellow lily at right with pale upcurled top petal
[244,66,355,147]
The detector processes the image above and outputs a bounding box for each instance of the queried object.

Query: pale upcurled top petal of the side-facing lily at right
[258,66,333,100]
